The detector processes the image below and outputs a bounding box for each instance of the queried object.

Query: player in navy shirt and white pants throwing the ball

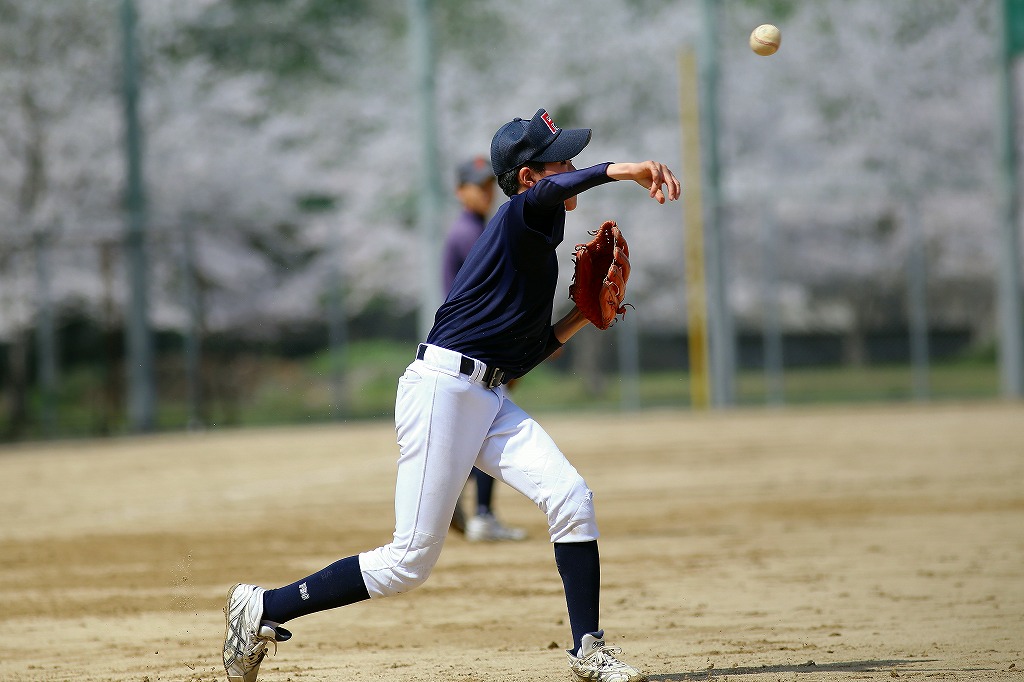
[223,110,680,682]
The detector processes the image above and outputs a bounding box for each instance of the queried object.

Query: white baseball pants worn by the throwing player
[359,345,598,597]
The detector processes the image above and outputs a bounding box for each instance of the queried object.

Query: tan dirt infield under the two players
[0,403,1024,682]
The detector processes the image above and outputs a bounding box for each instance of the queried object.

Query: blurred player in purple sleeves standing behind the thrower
[441,157,526,543]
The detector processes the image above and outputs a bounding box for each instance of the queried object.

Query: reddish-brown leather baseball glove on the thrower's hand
[569,220,630,329]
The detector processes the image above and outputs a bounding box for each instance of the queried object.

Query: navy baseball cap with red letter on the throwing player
[490,109,591,175]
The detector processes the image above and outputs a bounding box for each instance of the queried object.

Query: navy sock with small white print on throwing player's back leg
[263,556,370,624]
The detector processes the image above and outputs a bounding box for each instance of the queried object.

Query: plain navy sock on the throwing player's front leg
[555,540,601,653]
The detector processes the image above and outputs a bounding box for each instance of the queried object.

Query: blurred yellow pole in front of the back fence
[679,48,711,409]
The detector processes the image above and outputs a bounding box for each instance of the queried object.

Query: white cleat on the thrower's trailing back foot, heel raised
[224,583,292,682]
